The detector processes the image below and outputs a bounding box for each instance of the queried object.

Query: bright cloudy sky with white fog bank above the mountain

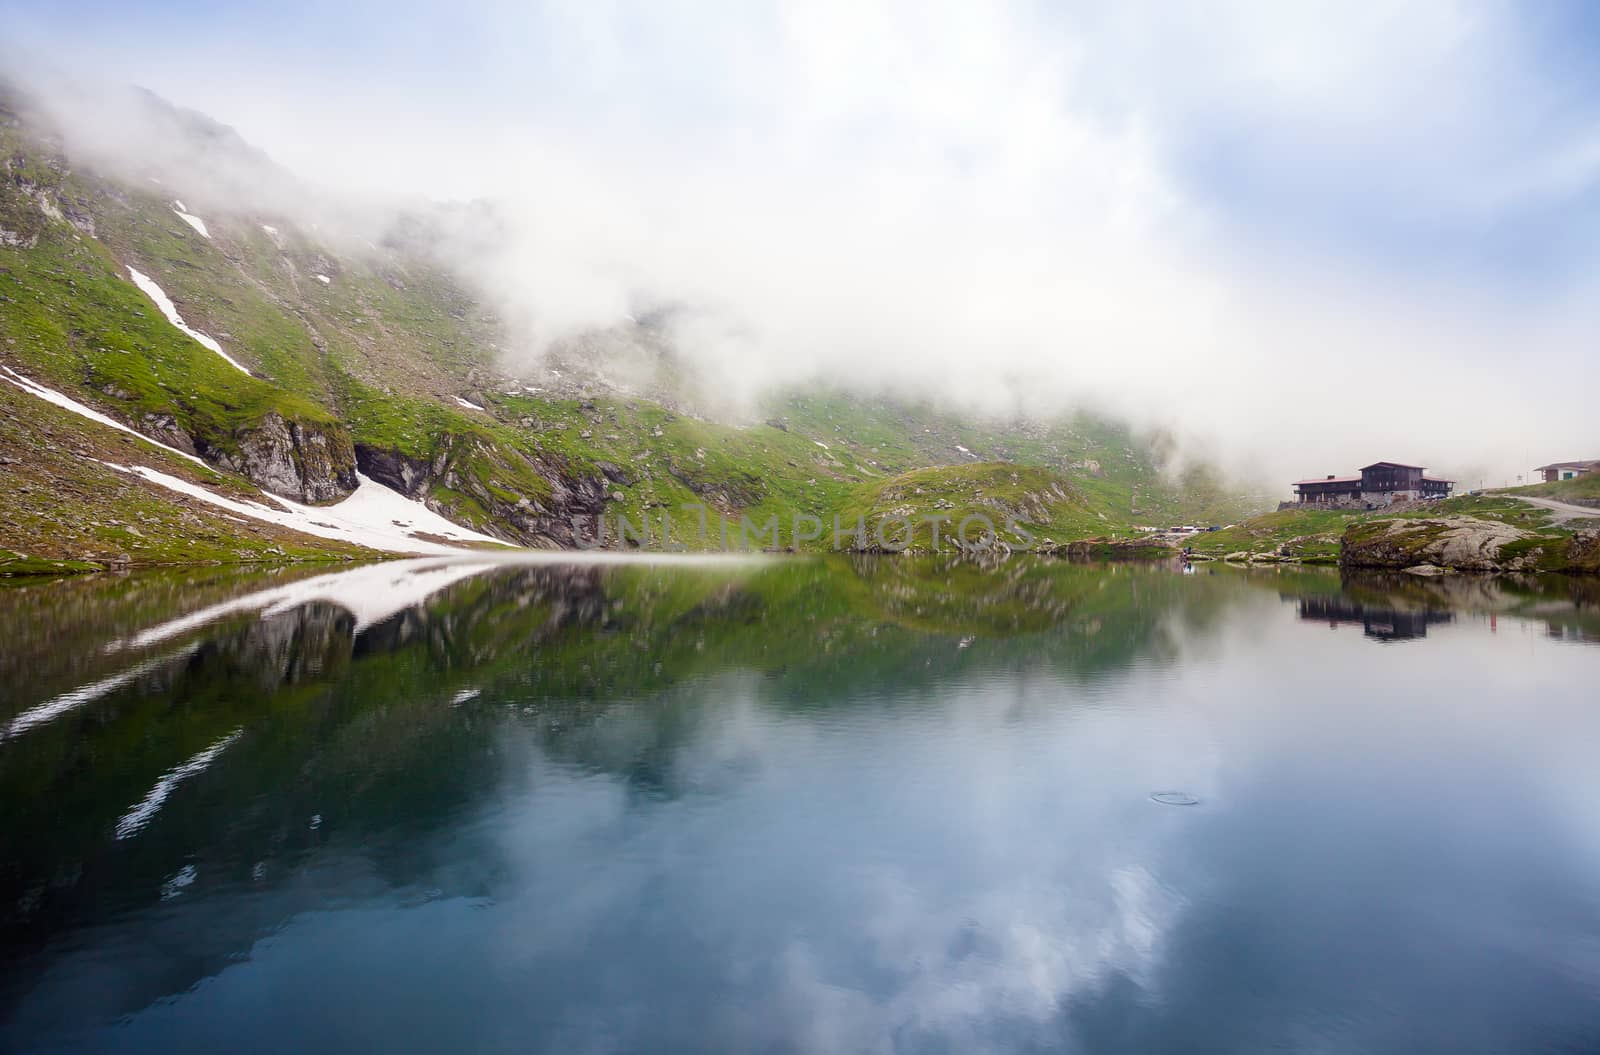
[6,0,1600,477]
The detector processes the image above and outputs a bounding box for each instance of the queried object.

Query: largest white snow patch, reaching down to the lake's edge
[106,463,506,554]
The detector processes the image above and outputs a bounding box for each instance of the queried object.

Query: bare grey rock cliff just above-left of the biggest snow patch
[200,413,357,503]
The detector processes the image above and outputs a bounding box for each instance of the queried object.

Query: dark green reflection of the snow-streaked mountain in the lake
[0,559,1594,1037]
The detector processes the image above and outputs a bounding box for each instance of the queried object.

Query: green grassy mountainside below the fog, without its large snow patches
[0,90,1256,567]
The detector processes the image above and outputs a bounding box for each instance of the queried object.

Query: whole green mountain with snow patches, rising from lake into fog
[0,86,1256,572]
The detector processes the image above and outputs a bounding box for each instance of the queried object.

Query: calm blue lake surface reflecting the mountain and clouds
[0,560,1600,1053]
